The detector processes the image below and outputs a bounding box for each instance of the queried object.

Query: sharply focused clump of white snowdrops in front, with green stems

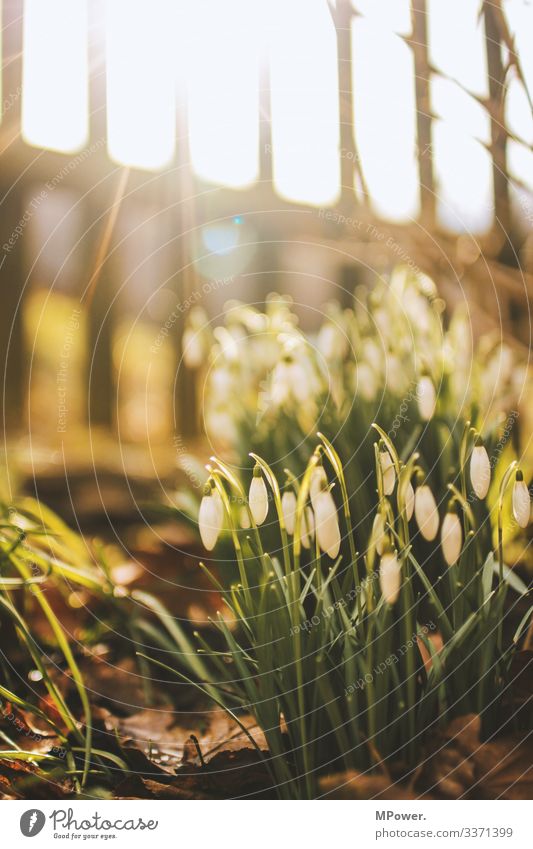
[149,434,531,798]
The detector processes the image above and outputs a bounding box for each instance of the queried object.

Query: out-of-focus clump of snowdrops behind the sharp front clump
[183,267,525,460]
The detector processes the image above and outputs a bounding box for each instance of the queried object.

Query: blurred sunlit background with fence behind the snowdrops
[0,0,533,526]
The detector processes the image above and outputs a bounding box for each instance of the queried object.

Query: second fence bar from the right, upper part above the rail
[409,0,435,224]
